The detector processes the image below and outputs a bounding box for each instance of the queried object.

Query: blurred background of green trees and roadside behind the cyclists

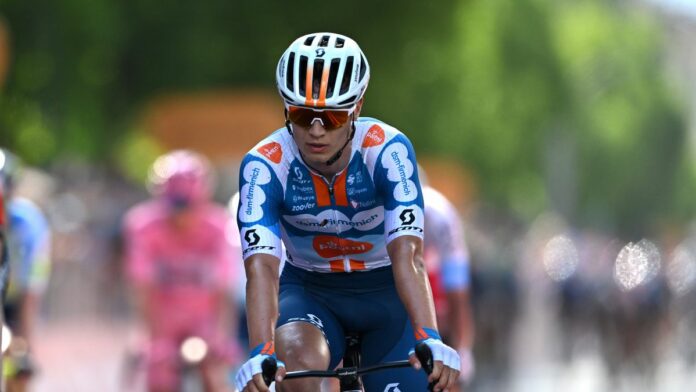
[0,0,696,391]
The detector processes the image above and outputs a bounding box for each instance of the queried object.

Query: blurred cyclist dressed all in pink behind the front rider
[124,150,239,392]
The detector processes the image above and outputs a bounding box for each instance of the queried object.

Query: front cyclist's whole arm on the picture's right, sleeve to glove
[373,135,460,390]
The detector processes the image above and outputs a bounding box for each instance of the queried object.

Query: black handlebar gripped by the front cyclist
[261,343,435,391]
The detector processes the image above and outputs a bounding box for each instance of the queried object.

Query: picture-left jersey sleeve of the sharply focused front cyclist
[237,154,284,260]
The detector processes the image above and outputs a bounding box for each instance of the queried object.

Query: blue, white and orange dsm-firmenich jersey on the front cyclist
[237,118,424,272]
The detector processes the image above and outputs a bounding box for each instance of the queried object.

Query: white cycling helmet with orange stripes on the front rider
[276,33,370,109]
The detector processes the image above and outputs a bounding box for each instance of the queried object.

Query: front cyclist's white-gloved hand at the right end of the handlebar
[408,328,461,392]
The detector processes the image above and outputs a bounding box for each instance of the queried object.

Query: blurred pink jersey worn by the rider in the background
[125,200,241,325]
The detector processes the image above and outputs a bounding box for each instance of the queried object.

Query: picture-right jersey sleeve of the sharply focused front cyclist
[374,134,424,244]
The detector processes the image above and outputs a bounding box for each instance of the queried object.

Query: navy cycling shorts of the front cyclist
[277,263,427,392]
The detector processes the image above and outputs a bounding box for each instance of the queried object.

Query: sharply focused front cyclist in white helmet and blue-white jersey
[236,33,459,391]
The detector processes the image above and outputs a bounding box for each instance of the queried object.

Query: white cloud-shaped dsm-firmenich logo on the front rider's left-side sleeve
[239,161,271,223]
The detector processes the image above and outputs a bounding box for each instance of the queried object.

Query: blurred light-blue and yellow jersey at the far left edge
[7,197,51,303]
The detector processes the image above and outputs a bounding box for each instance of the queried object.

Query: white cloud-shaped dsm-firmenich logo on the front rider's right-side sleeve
[382,143,418,202]
